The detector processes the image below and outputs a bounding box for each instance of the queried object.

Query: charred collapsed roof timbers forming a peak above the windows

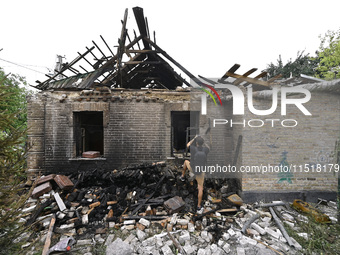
[36,7,193,90]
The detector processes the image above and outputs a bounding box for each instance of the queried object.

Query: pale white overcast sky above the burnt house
[0,0,340,85]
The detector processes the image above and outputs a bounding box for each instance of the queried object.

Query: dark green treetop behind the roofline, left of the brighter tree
[266,51,318,78]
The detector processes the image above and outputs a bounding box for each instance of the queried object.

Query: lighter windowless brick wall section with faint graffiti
[239,88,340,192]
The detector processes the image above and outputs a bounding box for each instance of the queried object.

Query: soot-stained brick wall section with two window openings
[28,92,233,173]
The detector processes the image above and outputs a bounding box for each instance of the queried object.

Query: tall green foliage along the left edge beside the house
[0,69,30,254]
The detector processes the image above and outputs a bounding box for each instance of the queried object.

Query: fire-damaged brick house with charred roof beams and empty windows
[27,7,340,201]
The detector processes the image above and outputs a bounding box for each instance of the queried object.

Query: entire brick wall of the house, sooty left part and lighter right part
[28,86,340,200]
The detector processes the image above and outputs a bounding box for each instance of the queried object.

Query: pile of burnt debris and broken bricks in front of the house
[17,162,336,255]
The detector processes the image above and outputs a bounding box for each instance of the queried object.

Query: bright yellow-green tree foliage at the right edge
[316,29,340,80]
